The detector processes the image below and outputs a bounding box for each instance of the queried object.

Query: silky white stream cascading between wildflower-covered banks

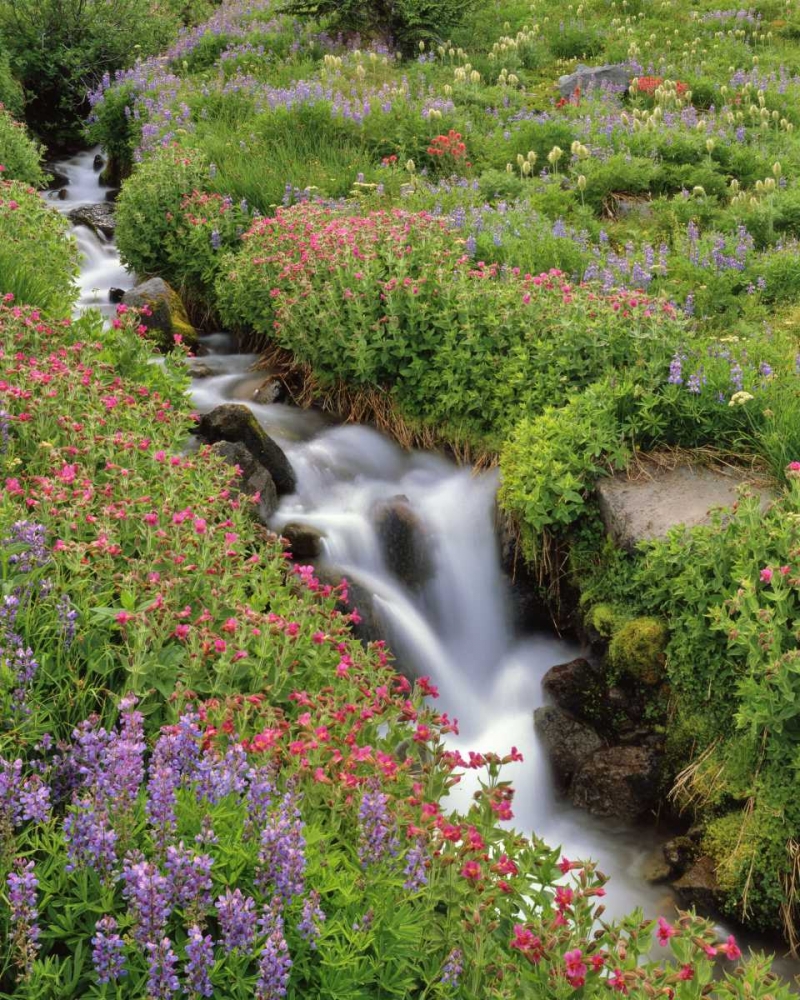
[47,149,798,979]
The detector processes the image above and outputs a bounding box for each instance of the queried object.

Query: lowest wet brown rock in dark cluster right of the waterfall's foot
[570,747,661,821]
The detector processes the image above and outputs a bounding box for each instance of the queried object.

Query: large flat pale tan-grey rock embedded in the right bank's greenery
[596,465,774,549]
